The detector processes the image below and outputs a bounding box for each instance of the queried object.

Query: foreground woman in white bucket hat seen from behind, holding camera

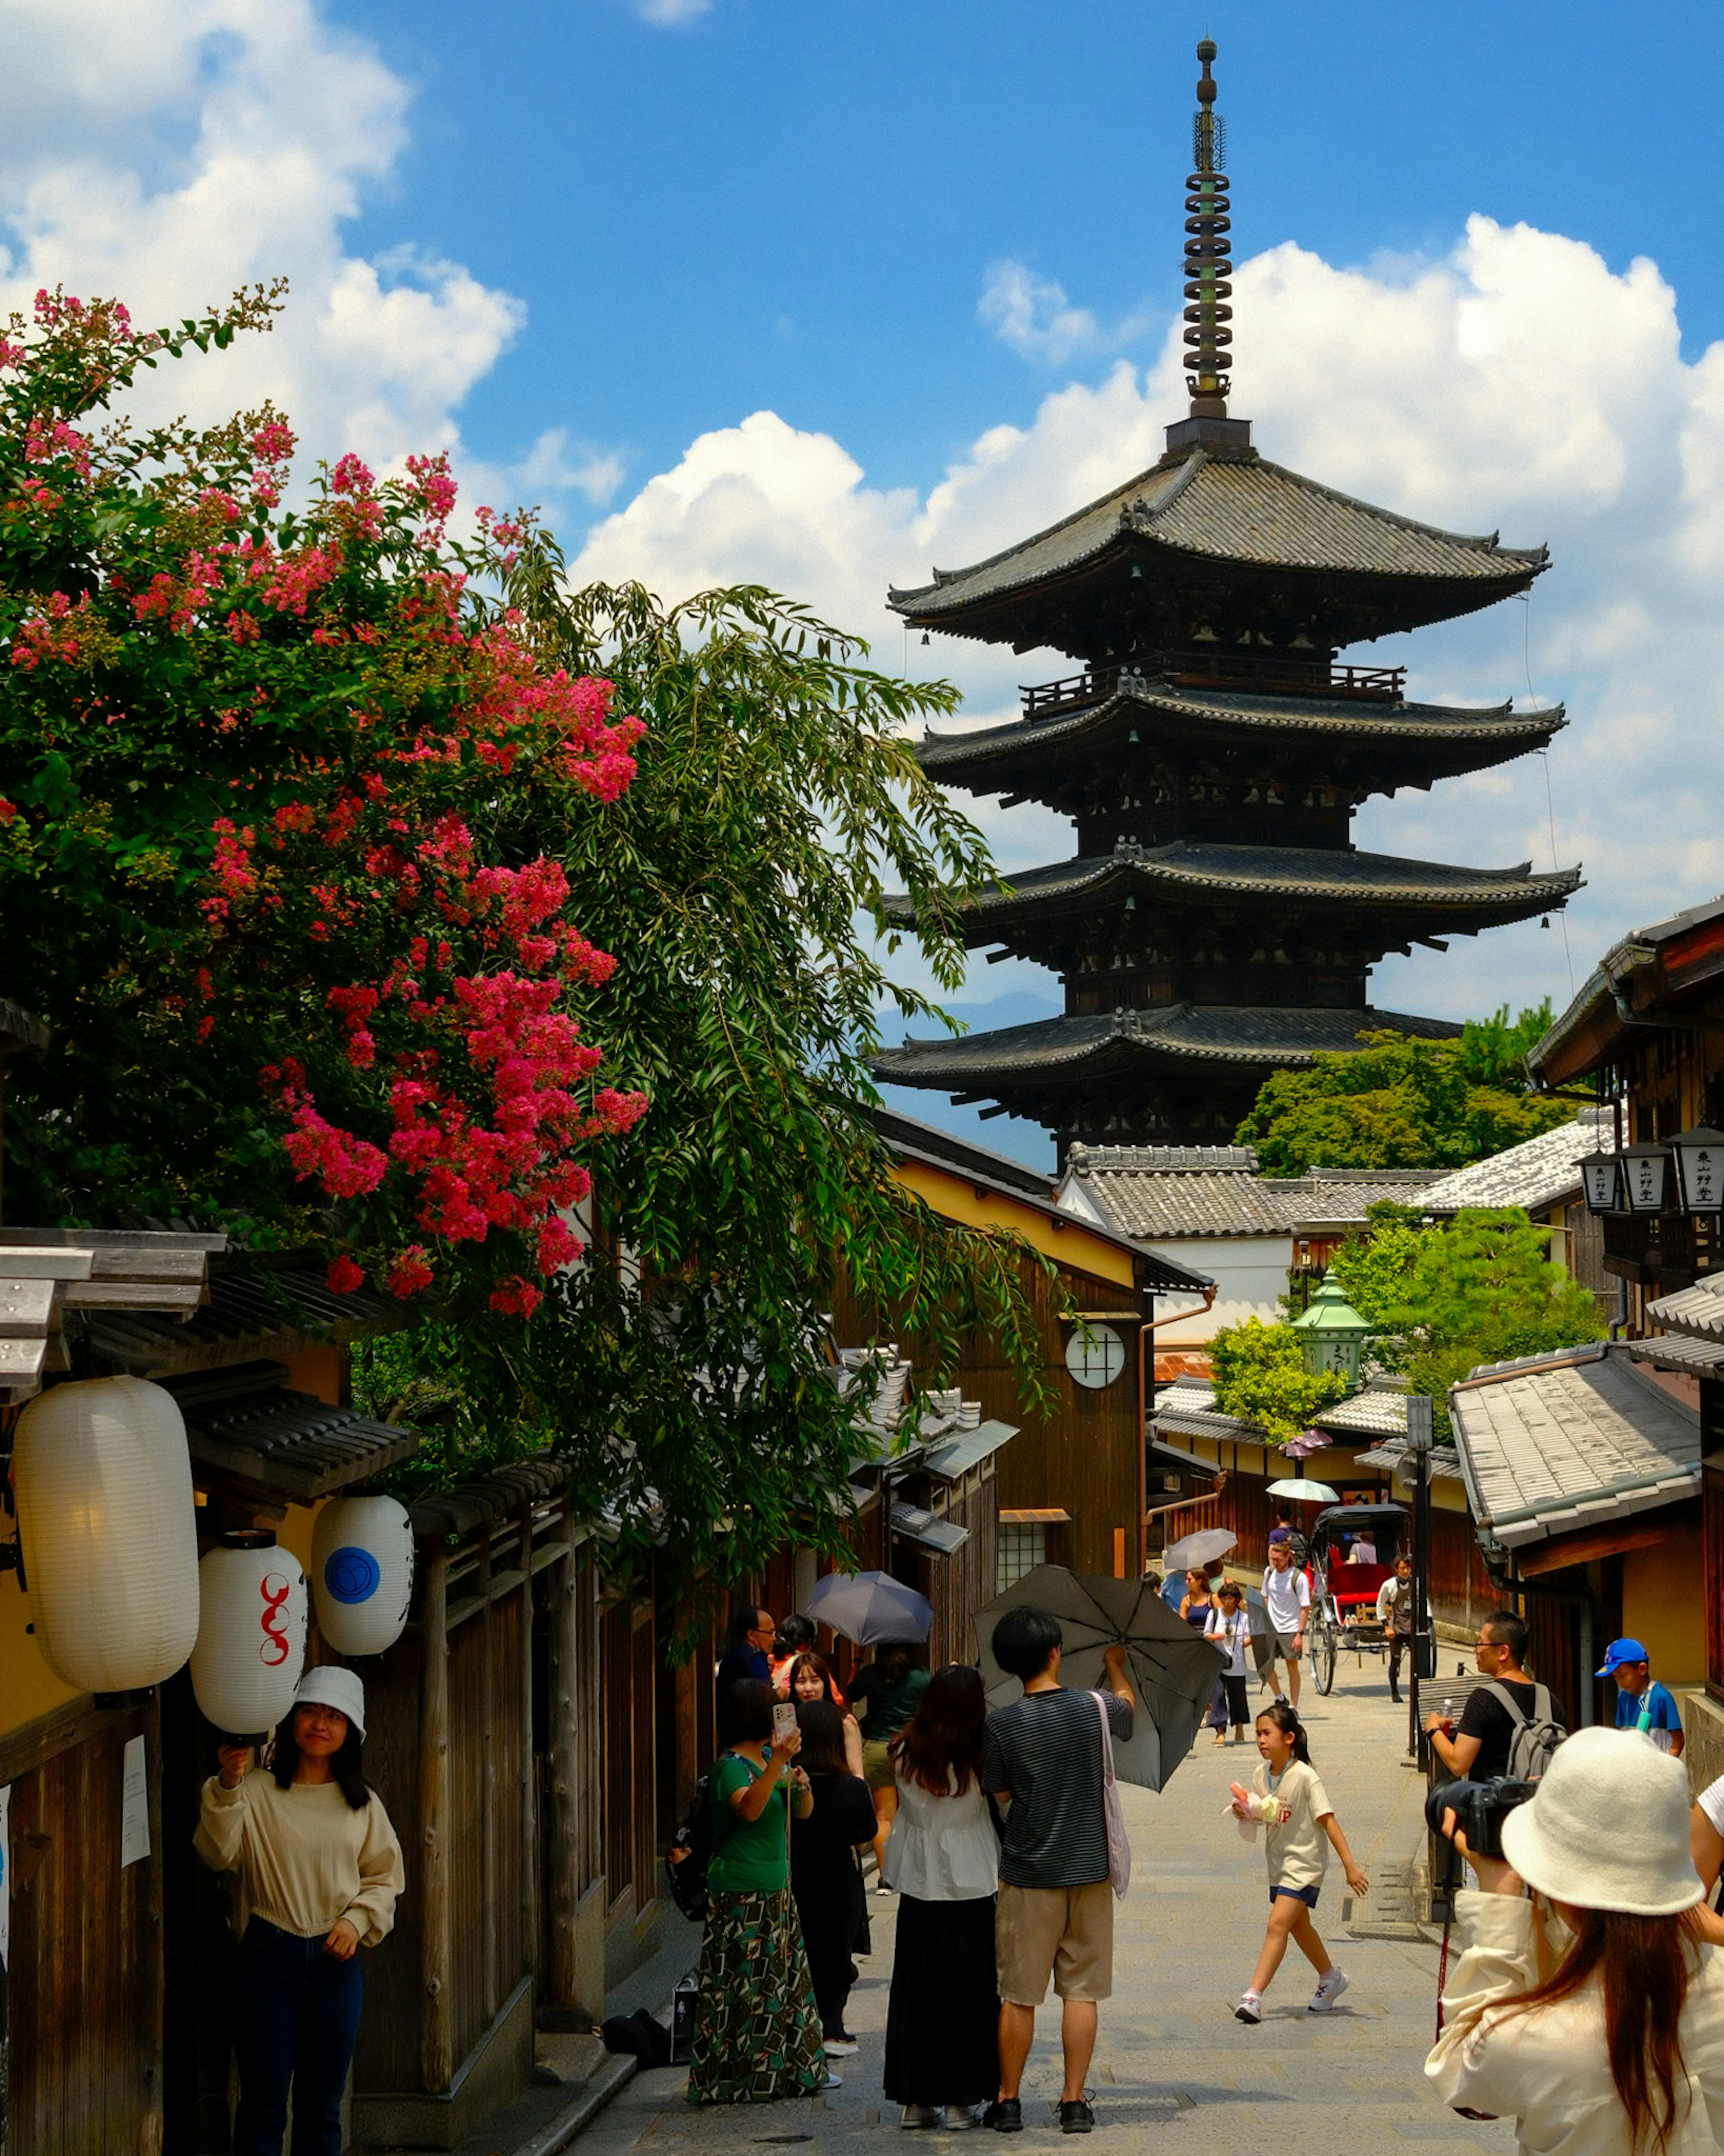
[1425,1729,1724,2156]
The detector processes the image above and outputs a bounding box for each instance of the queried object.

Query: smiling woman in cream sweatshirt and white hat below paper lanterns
[194,1664,405,2156]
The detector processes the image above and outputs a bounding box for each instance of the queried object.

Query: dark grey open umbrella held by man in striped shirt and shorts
[976,1565,1222,1790]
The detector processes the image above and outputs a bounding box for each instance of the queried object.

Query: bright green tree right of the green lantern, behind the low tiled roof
[1332,1205,1605,1427]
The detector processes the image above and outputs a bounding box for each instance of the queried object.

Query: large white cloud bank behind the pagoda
[577,218,1724,1013]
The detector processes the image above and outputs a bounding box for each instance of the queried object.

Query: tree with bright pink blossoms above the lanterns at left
[0,291,646,1322]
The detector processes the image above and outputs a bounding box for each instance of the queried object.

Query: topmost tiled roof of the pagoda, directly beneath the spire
[888,446,1549,651]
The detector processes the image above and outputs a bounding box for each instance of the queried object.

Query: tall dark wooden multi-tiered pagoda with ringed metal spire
[877,39,1579,1151]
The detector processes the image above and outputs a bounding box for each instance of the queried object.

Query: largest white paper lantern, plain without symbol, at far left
[13,1378,198,1693]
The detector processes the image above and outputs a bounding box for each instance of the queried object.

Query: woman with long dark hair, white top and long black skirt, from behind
[886,1664,1000,2130]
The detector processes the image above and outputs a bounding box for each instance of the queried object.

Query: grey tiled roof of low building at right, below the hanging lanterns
[1448,1343,1700,1550]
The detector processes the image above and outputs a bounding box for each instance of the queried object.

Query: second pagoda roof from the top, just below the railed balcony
[916,673,1567,794]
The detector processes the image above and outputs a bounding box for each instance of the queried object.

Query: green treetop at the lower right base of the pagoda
[1237,1002,1573,1175]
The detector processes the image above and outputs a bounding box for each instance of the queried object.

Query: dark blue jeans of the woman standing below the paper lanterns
[233,1917,364,2156]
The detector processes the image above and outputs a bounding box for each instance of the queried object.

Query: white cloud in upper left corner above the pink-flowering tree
[0,0,620,521]
